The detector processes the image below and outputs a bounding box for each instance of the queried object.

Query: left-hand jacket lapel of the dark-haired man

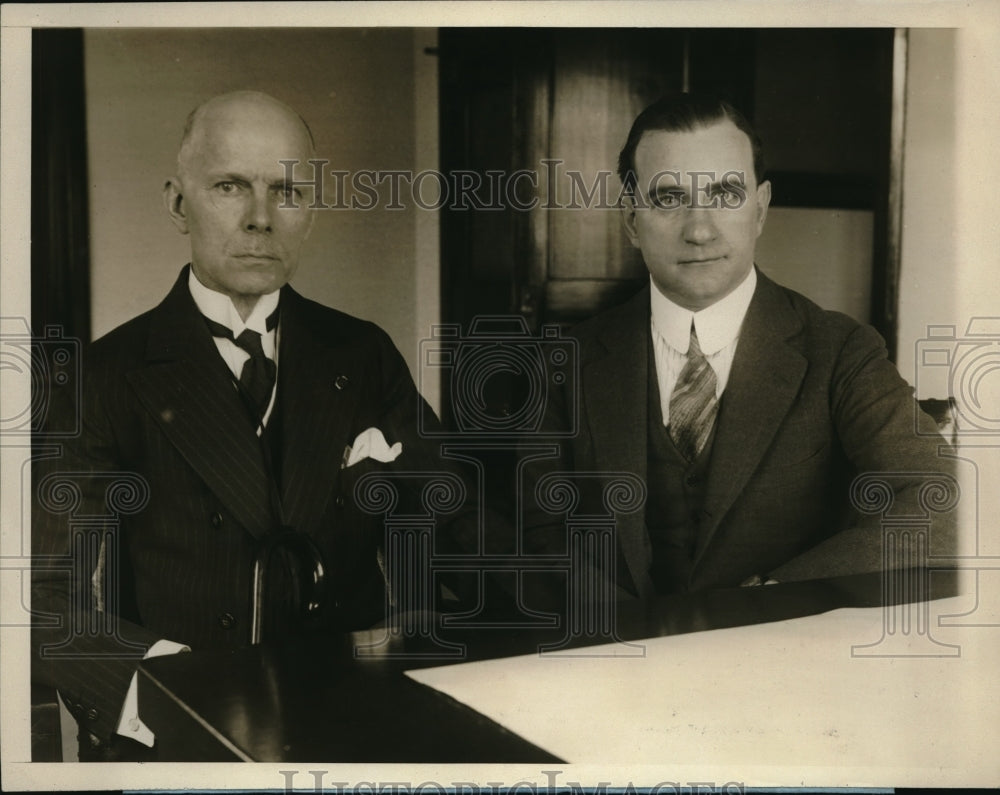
[583,287,650,595]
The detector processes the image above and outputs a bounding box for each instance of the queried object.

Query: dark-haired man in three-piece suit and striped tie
[525,94,954,600]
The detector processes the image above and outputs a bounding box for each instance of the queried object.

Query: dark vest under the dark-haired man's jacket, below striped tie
[646,344,715,593]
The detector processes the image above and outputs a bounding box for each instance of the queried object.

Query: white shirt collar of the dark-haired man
[649,267,757,356]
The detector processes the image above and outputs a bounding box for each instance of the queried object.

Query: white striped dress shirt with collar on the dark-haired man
[649,268,757,425]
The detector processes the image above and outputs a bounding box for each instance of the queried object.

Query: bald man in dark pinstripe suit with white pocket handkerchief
[33,92,454,759]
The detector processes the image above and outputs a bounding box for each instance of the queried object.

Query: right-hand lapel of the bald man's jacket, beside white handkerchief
[278,287,362,531]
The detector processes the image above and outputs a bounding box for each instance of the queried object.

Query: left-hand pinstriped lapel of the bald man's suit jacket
[127,268,274,536]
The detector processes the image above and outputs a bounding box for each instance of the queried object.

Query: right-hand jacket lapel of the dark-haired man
[695,271,807,565]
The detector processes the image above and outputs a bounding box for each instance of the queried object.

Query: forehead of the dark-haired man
[635,119,753,176]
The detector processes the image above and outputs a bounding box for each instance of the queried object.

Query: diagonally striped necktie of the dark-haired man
[669,321,719,461]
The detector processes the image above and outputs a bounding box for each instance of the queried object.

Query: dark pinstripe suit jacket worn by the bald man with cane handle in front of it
[33,268,450,737]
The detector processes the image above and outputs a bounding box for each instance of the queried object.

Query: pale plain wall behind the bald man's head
[85,28,439,408]
